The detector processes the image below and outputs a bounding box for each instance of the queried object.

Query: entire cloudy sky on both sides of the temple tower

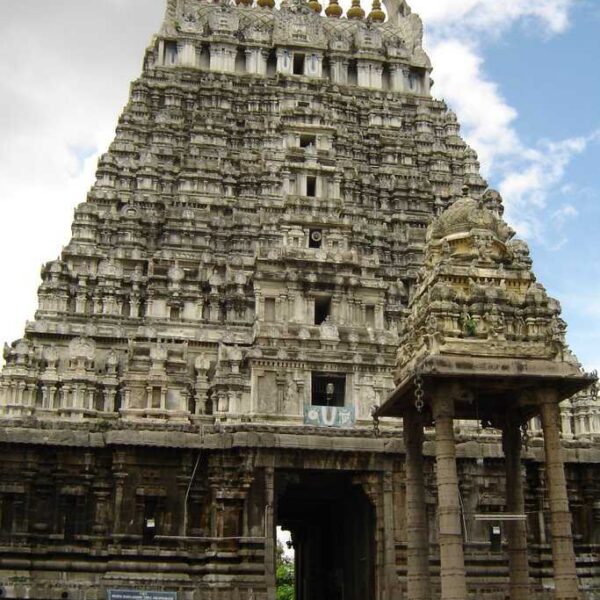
[0,0,600,368]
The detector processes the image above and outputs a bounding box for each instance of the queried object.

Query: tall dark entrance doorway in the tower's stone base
[275,471,375,600]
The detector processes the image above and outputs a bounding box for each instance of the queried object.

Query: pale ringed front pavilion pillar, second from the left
[432,388,467,600]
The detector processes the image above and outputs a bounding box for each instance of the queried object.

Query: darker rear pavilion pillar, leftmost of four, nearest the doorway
[404,408,431,600]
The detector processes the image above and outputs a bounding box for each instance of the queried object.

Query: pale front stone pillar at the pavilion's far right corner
[539,390,580,600]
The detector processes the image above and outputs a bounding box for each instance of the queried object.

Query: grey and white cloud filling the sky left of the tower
[0,0,164,343]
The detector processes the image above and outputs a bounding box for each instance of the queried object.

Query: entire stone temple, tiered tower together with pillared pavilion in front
[0,0,600,600]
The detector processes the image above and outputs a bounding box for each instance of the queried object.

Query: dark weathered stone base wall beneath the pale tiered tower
[0,426,600,600]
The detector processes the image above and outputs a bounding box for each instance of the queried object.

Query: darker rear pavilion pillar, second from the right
[502,419,530,600]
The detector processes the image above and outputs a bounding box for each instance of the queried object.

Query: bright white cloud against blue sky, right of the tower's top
[410,0,598,246]
